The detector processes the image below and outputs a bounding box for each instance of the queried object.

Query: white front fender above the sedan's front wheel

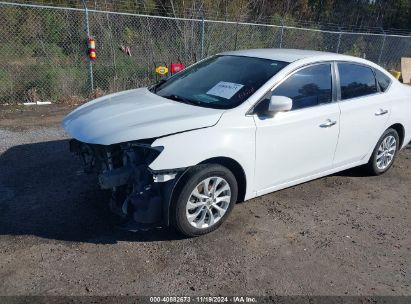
[149,114,256,200]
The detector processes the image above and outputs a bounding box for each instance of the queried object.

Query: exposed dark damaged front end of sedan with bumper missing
[70,139,184,231]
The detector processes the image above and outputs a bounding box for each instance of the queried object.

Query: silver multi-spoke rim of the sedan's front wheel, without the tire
[186,176,231,228]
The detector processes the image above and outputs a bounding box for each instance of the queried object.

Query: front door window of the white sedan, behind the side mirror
[273,63,332,110]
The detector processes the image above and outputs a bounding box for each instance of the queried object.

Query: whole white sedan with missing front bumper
[62,49,411,236]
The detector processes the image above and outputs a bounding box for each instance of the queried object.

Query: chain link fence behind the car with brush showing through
[0,2,411,104]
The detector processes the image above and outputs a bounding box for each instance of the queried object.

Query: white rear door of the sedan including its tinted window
[334,62,391,167]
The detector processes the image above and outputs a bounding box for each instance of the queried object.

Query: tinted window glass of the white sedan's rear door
[338,63,378,100]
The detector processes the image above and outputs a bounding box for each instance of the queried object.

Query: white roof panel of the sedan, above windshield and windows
[219,49,368,63]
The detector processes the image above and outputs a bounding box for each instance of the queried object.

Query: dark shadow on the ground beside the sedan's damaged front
[0,140,182,244]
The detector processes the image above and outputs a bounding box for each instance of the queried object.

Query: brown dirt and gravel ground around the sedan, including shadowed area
[0,105,411,296]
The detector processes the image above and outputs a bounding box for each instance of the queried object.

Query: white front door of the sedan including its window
[254,63,340,195]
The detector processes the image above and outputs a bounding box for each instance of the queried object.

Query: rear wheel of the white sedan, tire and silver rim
[366,128,400,175]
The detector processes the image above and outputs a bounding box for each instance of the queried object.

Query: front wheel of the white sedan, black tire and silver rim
[170,164,238,237]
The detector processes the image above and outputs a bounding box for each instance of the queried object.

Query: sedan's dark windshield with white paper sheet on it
[151,56,287,109]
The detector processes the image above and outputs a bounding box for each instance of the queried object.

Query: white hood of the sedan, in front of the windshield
[62,88,224,145]
